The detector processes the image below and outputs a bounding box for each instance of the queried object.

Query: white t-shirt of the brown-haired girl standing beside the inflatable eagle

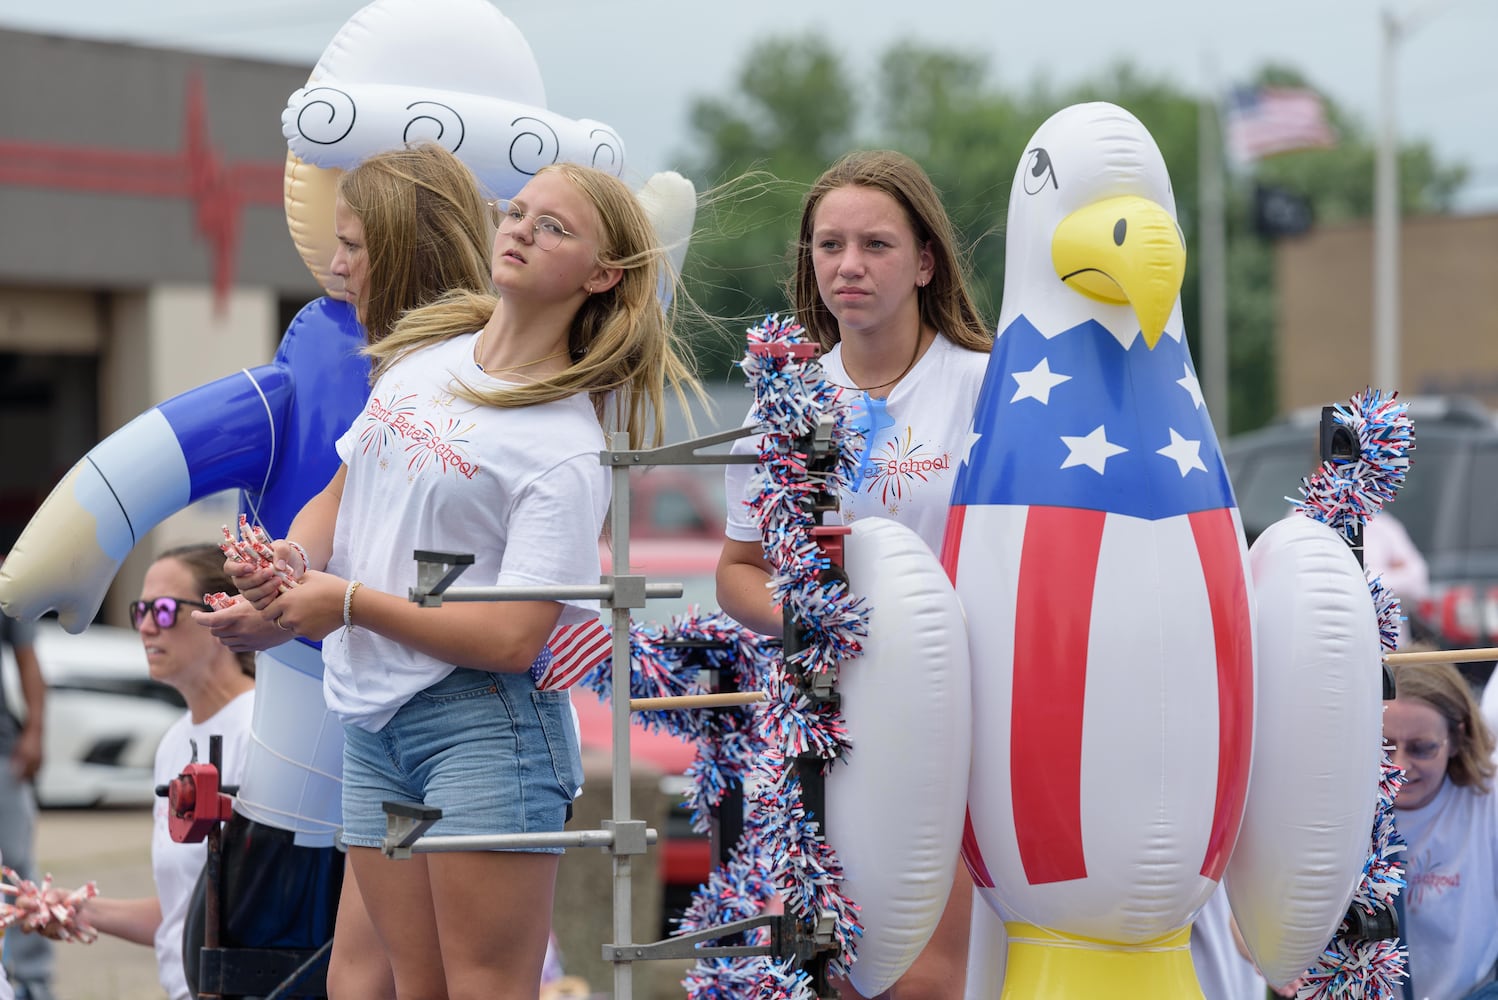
[725,337,989,552]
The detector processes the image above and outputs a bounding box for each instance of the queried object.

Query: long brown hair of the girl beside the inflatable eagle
[786,150,993,353]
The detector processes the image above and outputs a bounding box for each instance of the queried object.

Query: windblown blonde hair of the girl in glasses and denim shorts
[366,163,706,448]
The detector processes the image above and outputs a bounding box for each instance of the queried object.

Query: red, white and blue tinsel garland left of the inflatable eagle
[583,316,867,1000]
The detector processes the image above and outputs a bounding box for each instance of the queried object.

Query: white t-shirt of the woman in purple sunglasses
[151,690,255,1000]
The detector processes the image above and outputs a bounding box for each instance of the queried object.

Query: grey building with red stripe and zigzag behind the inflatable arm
[0,30,321,624]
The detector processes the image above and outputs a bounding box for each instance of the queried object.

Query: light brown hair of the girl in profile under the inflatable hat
[339,142,493,344]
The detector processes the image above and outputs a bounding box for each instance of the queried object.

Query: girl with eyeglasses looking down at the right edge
[1384,663,1498,1000]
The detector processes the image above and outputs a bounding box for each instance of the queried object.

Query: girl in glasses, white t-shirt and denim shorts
[229,156,695,1000]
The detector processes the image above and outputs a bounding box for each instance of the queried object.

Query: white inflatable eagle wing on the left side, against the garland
[827,518,972,997]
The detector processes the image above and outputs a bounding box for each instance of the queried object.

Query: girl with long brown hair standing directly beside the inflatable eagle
[718,150,993,1000]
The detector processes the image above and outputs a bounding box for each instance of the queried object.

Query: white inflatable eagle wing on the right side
[1225,513,1383,985]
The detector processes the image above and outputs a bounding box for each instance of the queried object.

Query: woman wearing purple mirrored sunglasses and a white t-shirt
[20,545,255,1000]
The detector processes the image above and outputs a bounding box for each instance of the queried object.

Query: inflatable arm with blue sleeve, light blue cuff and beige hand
[0,299,369,632]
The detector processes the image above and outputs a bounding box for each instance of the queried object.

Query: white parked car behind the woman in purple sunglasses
[0,620,183,808]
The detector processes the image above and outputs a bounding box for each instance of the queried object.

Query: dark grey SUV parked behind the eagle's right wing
[1222,397,1498,683]
